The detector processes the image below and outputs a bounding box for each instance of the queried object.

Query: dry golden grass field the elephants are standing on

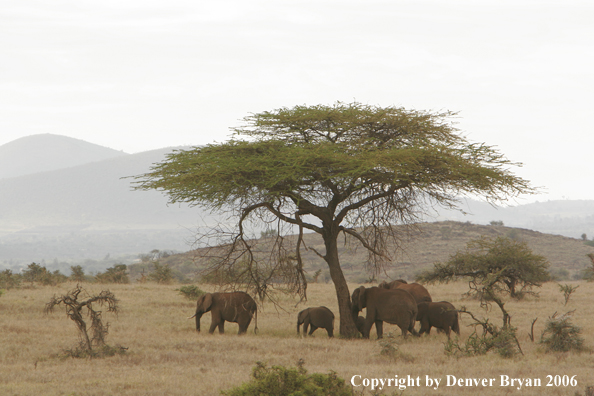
[0,282,594,395]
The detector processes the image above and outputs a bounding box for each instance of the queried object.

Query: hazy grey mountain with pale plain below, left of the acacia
[0,142,217,268]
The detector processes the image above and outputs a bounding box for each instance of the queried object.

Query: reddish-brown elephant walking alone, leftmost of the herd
[188,292,258,334]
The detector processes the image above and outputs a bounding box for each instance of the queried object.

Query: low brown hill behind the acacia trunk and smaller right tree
[160,221,594,283]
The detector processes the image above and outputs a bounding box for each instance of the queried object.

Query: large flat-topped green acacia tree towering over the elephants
[135,102,531,336]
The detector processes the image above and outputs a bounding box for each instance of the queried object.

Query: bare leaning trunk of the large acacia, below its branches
[323,233,357,338]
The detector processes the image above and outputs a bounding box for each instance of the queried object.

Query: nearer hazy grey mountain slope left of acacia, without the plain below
[0,148,212,233]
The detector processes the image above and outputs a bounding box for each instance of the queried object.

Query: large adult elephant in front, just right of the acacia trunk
[351,286,418,338]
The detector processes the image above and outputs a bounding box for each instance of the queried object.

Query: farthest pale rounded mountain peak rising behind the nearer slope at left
[0,133,129,179]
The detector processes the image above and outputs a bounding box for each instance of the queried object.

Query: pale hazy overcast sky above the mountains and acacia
[0,0,594,202]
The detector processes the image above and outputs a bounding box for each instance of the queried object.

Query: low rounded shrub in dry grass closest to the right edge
[540,311,586,352]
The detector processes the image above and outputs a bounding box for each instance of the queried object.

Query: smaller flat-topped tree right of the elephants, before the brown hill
[417,237,549,327]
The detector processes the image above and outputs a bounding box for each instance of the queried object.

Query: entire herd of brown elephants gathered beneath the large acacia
[188,280,460,338]
